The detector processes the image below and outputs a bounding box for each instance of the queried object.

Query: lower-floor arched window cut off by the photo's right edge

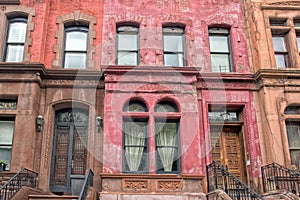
[284,106,300,169]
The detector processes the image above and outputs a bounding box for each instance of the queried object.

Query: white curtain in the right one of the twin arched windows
[156,123,177,172]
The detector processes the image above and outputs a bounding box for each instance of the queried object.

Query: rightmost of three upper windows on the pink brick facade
[208,28,233,72]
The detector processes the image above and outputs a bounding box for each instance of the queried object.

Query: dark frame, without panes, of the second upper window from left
[62,26,89,69]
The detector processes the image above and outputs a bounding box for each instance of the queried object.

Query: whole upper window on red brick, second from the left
[64,26,88,69]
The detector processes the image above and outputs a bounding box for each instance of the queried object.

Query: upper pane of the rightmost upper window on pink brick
[209,36,229,53]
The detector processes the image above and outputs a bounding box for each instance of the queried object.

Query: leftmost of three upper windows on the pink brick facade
[116,25,139,65]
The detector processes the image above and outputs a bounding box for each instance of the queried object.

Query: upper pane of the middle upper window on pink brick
[164,35,183,52]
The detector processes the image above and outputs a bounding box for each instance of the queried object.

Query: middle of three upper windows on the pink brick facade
[163,27,186,66]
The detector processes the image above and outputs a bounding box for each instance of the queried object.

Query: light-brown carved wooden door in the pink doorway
[211,126,247,182]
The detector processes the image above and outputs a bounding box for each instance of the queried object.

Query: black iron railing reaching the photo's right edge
[261,163,300,197]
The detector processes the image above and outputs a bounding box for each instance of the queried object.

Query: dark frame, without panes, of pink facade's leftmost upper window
[116,24,140,66]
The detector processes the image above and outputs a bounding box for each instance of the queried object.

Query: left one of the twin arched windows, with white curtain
[123,100,148,173]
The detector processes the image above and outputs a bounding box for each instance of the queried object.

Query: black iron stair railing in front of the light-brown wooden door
[206,162,262,200]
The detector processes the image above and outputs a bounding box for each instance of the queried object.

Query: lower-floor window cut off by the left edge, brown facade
[0,119,15,170]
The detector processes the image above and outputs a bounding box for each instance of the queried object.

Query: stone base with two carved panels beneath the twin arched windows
[100,174,206,200]
